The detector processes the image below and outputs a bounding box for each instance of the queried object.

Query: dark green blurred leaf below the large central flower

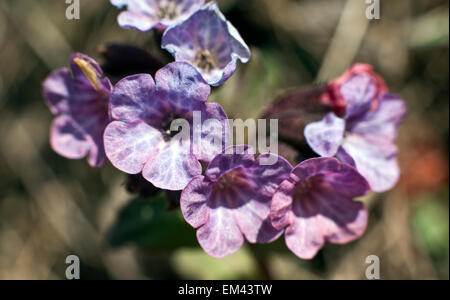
[109,194,198,252]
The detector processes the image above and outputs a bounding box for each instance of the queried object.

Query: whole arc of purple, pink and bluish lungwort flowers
[43,0,406,259]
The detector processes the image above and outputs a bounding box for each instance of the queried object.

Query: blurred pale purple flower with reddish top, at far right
[305,65,406,192]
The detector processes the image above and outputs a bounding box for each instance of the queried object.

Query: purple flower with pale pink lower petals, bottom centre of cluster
[180,146,292,258]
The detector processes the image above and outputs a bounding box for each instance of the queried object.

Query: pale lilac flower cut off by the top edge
[111,0,205,32]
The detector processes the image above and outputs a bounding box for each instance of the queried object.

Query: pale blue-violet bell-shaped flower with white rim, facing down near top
[162,2,250,86]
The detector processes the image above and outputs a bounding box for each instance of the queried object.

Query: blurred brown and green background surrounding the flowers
[0,0,449,279]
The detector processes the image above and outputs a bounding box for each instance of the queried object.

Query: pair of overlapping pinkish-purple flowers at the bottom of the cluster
[181,147,370,259]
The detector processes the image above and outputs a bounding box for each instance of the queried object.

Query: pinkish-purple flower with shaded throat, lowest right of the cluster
[270,158,370,259]
